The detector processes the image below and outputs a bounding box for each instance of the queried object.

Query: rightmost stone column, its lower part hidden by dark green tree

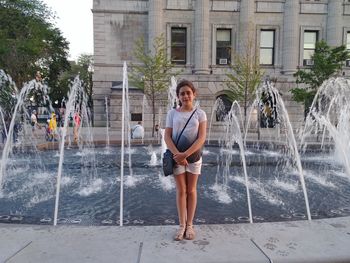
[327,0,343,47]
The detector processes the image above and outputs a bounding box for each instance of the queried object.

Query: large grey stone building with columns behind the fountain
[92,0,350,136]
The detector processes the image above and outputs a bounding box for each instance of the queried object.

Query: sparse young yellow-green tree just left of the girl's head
[130,36,179,136]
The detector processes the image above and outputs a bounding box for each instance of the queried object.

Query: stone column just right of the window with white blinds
[282,0,299,75]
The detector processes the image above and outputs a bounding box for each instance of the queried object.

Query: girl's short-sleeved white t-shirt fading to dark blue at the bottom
[166,109,207,152]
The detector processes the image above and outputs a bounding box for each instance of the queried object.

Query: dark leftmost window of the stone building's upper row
[171,27,187,65]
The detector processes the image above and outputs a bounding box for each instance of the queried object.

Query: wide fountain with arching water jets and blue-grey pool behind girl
[0,67,350,226]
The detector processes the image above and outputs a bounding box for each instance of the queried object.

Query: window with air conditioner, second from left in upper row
[216,29,232,65]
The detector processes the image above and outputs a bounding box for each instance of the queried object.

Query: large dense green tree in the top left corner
[0,0,69,88]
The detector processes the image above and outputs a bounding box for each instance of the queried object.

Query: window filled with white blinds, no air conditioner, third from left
[260,30,275,65]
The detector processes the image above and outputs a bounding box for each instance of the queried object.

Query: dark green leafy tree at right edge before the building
[291,40,350,114]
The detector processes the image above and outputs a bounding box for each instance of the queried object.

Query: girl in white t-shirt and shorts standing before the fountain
[164,80,207,241]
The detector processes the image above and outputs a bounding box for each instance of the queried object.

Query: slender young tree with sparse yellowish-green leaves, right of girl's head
[224,36,263,125]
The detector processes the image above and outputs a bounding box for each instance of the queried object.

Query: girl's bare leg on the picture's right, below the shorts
[186,172,199,225]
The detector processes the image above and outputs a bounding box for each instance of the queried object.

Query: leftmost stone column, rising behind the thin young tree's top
[148,0,165,52]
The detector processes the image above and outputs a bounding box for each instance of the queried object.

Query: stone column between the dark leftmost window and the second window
[194,0,210,74]
